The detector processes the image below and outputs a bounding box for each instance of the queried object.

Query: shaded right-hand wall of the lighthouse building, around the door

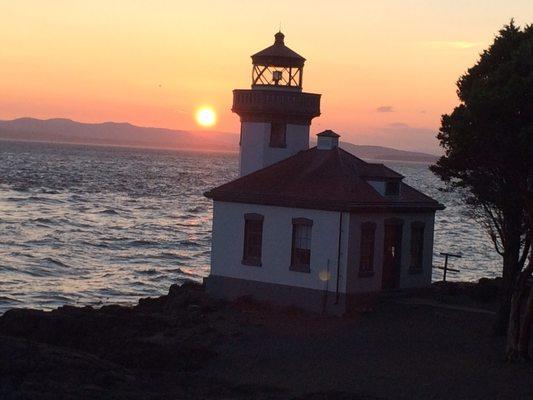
[347,212,435,293]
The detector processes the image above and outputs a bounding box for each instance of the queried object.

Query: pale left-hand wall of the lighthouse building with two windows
[211,201,350,293]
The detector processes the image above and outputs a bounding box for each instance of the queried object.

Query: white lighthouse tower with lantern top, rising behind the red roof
[232,32,320,176]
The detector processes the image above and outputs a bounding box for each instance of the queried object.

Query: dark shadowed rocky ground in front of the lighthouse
[0,283,533,399]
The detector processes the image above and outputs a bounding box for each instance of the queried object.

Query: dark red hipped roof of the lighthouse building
[205,147,444,211]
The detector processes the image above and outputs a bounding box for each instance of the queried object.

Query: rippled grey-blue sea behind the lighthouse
[0,141,501,313]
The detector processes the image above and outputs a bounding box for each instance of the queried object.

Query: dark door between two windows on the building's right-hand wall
[381,222,402,290]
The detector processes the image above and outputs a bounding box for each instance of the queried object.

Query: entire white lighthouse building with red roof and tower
[205,32,443,314]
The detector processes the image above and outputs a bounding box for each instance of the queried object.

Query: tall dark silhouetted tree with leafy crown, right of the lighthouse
[430,20,533,334]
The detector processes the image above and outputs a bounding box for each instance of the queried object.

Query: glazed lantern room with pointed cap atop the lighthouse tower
[252,32,305,91]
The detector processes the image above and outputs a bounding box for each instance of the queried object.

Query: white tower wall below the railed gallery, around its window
[239,122,309,176]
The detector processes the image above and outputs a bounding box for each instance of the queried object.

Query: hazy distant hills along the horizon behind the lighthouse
[0,118,437,162]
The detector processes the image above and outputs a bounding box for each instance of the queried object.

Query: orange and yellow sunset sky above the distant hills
[0,0,533,153]
